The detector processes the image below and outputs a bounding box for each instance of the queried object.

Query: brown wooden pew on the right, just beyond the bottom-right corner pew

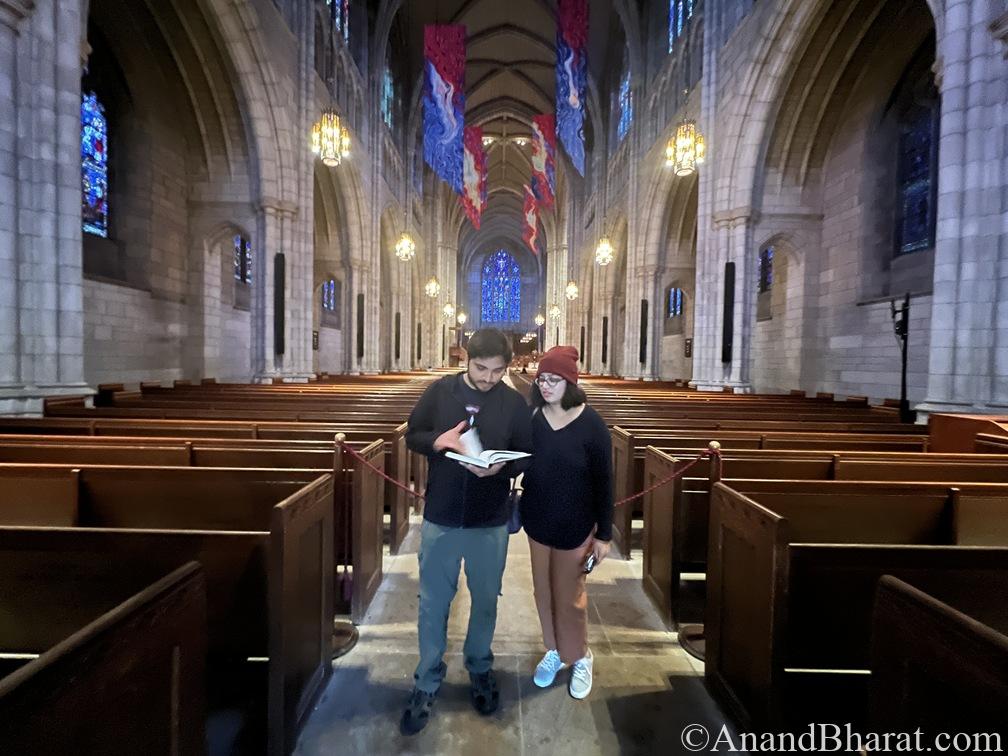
[705,483,1008,730]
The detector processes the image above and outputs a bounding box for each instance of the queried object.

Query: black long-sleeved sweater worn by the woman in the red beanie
[521,405,613,549]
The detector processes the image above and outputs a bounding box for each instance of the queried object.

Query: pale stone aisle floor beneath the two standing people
[295,521,737,756]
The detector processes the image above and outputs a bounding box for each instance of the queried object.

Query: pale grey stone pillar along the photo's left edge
[0,0,91,413]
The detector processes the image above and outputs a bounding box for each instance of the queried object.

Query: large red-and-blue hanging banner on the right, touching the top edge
[556,0,588,175]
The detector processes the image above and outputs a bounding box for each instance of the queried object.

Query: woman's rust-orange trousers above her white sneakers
[528,535,593,664]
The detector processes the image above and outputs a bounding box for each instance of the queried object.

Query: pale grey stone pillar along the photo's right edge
[918,0,1008,411]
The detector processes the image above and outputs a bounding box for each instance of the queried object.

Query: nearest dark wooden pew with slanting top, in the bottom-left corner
[0,553,207,756]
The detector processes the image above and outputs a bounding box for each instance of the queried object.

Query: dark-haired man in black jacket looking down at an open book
[400,329,532,735]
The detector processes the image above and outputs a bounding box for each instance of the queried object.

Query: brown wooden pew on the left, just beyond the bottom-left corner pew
[0,465,335,754]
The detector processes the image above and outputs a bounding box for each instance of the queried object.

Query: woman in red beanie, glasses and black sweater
[521,347,613,699]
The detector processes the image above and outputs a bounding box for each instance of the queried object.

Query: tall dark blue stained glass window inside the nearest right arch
[896,109,937,255]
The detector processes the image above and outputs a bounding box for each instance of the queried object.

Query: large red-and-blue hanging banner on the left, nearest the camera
[423,24,466,195]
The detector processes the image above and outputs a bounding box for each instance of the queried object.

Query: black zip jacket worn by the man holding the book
[406,374,532,527]
